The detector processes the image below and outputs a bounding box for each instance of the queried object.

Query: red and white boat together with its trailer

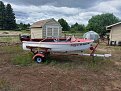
[22,36,111,63]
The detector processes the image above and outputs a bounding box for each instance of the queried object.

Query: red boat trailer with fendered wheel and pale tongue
[27,43,111,63]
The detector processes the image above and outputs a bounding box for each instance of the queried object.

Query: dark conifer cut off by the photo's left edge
[0,1,5,29]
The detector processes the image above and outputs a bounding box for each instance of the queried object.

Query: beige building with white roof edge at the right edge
[106,22,121,45]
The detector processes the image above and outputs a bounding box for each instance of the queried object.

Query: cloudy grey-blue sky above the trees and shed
[2,0,121,25]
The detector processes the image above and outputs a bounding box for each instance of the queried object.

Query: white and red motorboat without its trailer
[22,36,93,52]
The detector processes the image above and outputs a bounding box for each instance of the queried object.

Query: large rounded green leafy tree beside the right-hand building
[87,13,120,36]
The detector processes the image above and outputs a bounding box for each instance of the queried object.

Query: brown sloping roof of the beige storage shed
[31,18,55,28]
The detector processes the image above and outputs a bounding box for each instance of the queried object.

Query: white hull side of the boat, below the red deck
[23,41,93,52]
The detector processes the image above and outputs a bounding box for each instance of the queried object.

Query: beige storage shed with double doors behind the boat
[31,18,62,39]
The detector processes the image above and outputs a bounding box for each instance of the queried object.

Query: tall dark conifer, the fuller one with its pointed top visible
[5,4,16,30]
